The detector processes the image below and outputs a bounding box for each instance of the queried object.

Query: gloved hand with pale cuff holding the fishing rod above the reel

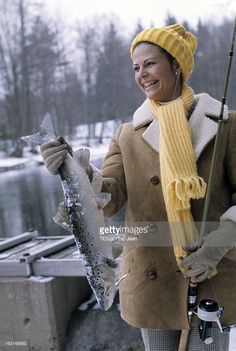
[181,220,236,282]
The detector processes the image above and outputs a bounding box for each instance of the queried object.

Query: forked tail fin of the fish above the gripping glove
[20,113,57,145]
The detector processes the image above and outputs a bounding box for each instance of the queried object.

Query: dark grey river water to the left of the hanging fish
[0,166,69,237]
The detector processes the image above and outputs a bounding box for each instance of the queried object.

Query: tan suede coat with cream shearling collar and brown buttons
[102,94,236,329]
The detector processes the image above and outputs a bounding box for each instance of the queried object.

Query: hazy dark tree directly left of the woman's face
[96,22,143,129]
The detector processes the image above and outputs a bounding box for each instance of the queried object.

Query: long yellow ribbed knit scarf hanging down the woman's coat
[148,85,206,265]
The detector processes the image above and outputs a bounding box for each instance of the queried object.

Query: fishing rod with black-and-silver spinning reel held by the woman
[178,17,236,351]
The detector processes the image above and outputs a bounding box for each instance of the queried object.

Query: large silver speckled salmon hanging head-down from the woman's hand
[21,114,116,310]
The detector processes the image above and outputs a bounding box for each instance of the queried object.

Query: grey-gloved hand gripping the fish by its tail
[40,137,68,175]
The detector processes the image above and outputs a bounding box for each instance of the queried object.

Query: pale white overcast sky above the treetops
[43,0,236,30]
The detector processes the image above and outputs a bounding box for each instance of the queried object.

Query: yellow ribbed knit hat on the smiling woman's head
[130,24,197,81]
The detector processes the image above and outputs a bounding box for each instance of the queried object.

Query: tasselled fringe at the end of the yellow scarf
[167,176,206,210]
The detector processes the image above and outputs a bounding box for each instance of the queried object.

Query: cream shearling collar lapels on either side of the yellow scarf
[133,93,228,159]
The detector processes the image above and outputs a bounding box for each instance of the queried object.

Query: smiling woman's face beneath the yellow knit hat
[133,43,181,102]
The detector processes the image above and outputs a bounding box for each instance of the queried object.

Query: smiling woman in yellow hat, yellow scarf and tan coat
[41,24,236,351]
